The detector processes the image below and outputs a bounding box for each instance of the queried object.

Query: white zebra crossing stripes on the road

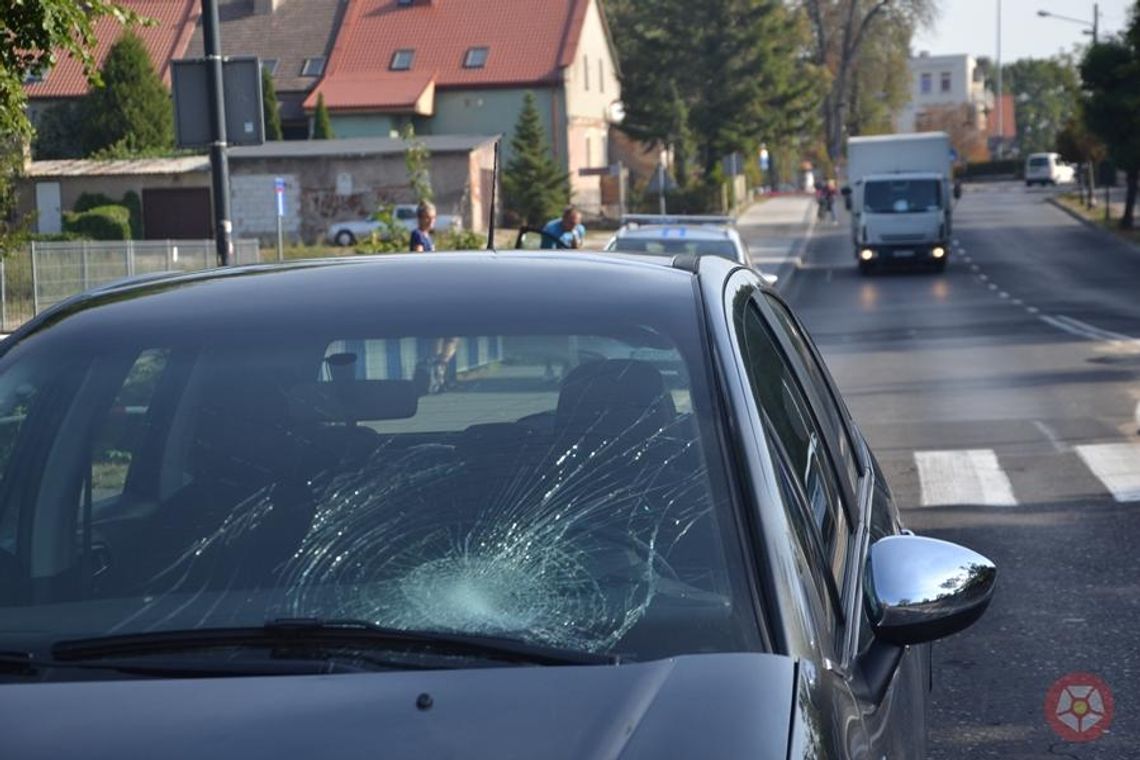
[913,442,1140,507]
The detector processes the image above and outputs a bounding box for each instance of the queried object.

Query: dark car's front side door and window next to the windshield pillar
[724,270,871,758]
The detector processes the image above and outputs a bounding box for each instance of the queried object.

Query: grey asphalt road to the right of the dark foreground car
[785,183,1140,760]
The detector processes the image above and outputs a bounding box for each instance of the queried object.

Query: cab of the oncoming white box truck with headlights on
[850,172,953,271]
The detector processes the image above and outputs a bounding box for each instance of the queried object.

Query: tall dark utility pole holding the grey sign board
[202,0,234,267]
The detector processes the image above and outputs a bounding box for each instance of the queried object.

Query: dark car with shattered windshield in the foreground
[0,253,995,759]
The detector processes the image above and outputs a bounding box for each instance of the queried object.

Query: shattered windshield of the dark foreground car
[0,320,757,659]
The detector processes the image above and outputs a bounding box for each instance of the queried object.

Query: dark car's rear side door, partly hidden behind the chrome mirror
[756,292,929,757]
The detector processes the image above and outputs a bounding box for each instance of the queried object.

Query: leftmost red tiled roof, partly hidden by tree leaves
[26,0,201,98]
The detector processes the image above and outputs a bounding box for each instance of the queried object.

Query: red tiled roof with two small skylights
[306,0,592,109]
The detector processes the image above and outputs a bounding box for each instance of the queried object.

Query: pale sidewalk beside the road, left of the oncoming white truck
[736,195,815,289]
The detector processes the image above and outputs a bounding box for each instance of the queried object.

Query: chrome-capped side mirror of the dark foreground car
[866,536,998,645]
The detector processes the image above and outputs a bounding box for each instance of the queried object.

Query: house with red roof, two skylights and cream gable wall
[307,0,621,211]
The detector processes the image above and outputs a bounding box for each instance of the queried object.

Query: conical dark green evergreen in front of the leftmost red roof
[82,31,174,155]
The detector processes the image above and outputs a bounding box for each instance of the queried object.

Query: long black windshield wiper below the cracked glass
[51,618,619,665]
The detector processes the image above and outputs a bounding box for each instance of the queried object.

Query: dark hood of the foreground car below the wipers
[0,654,795,760]
